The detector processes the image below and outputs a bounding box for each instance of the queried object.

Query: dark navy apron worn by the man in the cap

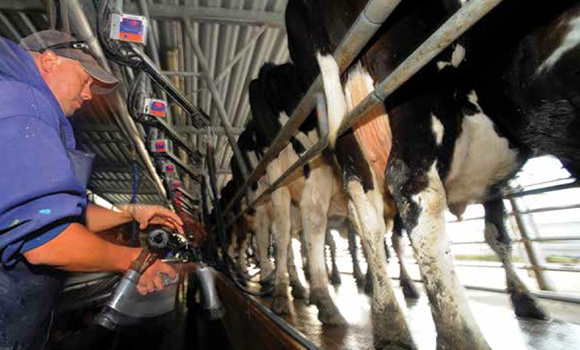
[0,126,95,350]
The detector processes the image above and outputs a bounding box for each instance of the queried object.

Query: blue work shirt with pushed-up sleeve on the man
[0,38,87,265]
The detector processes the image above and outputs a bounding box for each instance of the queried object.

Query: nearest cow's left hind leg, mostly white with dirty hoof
[346,180,415,349]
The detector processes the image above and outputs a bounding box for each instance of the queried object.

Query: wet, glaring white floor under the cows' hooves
[254,274,580,350]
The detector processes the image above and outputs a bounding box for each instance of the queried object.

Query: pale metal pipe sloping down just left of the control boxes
[68,0,167,198]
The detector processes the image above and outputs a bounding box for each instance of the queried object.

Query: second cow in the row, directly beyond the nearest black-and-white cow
[249,64,346,325]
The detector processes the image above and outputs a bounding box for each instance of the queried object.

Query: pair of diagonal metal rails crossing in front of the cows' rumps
[215,0,502,230]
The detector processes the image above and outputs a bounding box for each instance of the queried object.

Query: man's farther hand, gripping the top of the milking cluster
[119,204,183,234]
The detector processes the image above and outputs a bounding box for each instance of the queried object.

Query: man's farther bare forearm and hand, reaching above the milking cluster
[85,204,183,232]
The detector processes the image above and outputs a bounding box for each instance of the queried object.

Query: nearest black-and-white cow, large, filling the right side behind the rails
[286,0,580,349]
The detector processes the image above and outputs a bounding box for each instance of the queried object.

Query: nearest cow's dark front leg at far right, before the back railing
[484,198,548,320]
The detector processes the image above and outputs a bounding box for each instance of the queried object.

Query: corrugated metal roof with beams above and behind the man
[0,0,288,213]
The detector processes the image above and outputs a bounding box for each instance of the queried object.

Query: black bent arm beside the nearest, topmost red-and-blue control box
[97,0,210,128]
